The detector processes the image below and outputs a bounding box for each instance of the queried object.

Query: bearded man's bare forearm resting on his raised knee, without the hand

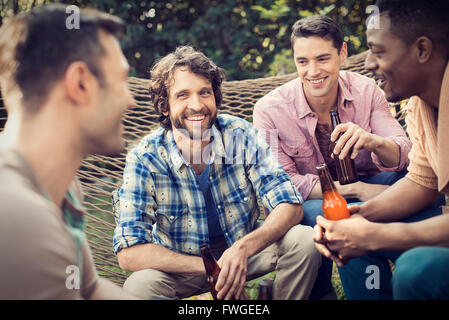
[234,203,303,257]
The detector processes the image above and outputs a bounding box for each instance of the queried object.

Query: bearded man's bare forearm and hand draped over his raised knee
[216,203,303,299]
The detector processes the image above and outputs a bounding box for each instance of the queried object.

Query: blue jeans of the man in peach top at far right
[338,195,449,300]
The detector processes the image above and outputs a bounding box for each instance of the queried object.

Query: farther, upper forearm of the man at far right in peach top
[360,178,440,222]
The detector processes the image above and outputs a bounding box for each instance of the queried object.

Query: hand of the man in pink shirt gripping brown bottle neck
[331,122,382,159]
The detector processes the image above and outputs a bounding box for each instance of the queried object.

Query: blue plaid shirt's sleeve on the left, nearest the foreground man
[113,150,156,253]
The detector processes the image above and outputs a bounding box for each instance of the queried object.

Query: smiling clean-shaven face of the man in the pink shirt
[293,36,347,101]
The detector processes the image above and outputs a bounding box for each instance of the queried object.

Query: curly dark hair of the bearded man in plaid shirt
[149,46,226,130]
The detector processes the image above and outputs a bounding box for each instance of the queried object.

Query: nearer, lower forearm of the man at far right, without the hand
[371,214,449,251]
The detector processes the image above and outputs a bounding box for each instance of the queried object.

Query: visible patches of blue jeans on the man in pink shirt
[301,170,407,299]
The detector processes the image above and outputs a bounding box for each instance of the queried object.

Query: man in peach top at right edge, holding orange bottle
[314,0,449,300]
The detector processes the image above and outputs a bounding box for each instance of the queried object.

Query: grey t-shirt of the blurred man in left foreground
[0,150,98,299]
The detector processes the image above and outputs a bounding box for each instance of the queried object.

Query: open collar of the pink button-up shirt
[295,72,354,118]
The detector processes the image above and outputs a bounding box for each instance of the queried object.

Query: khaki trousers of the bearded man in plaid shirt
[123,225,322,300]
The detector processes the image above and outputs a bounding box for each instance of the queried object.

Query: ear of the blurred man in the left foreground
[64,61,96,104]
